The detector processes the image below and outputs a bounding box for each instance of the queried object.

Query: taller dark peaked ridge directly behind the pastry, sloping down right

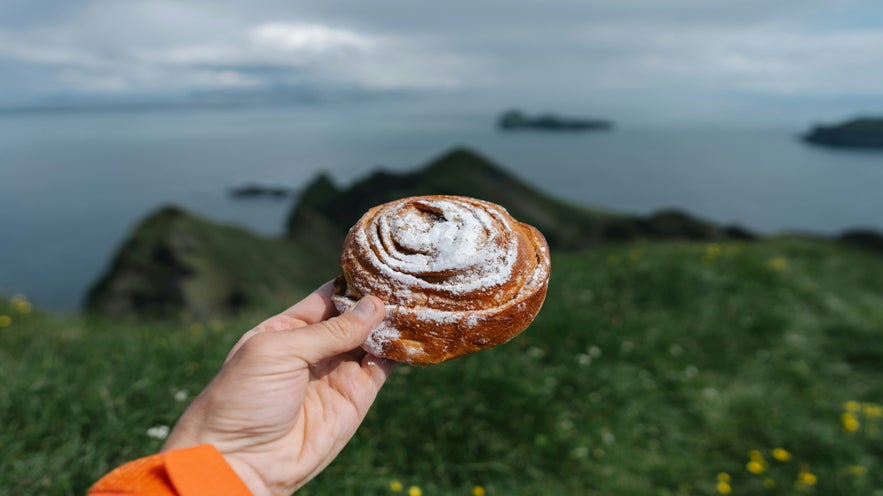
[288,148,754,249]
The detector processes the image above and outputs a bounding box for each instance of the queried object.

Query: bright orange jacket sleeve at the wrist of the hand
[88,444,251,496]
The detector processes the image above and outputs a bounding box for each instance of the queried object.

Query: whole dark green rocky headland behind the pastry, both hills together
[87,149,768,320]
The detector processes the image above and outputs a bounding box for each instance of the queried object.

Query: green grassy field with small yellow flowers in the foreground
[0,239,883,496]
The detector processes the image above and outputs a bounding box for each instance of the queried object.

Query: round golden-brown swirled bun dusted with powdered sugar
[334,196,550,364]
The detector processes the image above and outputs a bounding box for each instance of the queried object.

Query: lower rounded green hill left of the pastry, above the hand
[87,207,337,320]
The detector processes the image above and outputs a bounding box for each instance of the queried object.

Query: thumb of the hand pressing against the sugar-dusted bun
[282,295,386,365]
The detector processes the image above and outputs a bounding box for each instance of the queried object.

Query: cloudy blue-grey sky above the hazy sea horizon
[0,0,883,123]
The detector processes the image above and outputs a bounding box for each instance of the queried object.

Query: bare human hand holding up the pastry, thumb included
[163,283,395,496]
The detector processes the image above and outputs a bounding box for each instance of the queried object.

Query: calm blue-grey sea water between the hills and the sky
[0,104,883,310]
